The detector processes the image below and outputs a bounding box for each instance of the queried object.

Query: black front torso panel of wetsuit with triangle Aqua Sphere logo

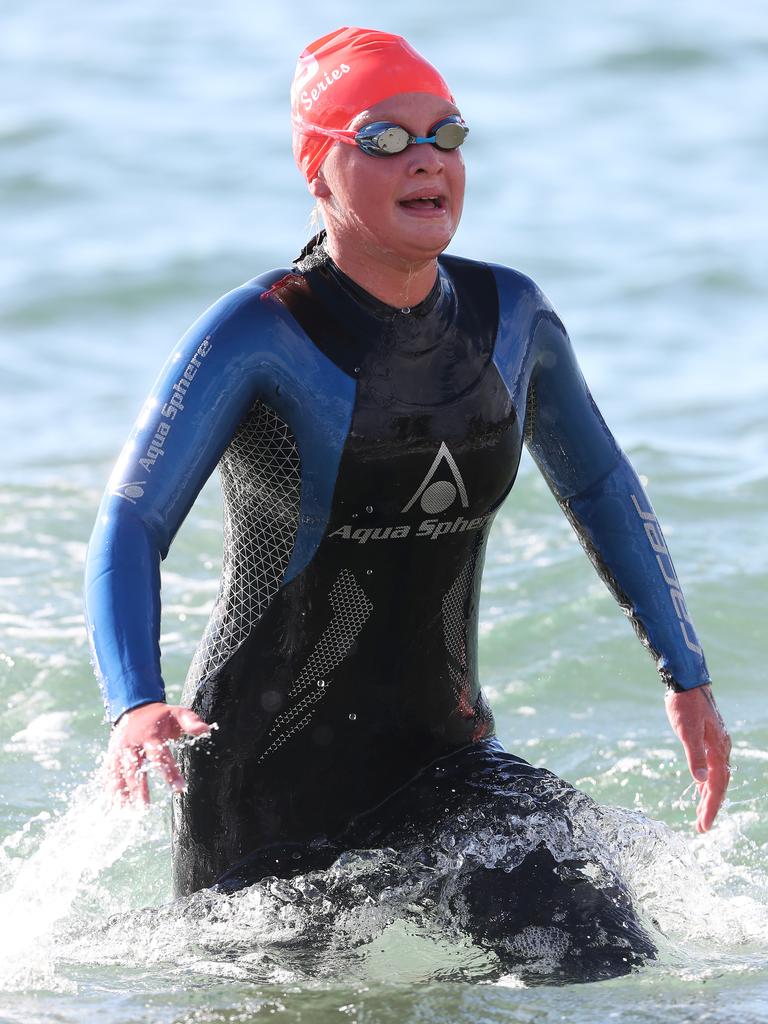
[177,245,522,888]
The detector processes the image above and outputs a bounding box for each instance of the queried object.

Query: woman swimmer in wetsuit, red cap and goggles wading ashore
[86,28,730,980]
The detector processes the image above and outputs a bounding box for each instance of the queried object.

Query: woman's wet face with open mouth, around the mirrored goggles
[310,92,465,266]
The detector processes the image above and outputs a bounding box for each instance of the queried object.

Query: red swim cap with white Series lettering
[291,28,454,181]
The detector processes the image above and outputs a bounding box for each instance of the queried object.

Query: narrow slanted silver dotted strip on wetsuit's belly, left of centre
[259,569,374,761]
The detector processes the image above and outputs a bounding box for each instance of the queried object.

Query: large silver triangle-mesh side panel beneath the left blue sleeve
[184,401,301,700]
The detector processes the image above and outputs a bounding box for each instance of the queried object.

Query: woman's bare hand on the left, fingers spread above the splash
[104,702,211,805]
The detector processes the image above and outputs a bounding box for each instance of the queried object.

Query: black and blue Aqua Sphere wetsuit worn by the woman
[86,240,709,978]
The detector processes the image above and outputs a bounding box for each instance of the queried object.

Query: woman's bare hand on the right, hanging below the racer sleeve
[666,683,731,833]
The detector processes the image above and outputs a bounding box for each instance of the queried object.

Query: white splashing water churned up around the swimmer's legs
[0,779,768,992]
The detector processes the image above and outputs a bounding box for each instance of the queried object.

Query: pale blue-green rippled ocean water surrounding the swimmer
[0,0,768,1024]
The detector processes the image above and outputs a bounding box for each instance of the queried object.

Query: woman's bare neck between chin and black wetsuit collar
[326,232,437,309]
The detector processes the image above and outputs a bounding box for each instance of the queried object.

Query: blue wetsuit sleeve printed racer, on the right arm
[499,274,710,689]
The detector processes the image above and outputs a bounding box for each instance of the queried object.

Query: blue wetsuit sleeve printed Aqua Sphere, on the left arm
[85,271,353,721]
